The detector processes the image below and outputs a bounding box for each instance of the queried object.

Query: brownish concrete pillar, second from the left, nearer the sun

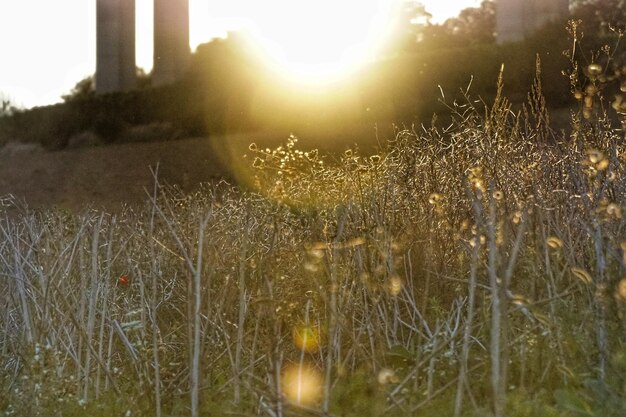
[152,0,191,86]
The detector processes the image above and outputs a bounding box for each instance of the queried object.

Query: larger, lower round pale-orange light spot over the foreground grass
[282,364,323,405]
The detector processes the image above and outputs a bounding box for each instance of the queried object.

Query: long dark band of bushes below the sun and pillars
[0,23,584,149]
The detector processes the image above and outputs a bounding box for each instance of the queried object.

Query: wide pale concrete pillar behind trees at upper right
[496,0,569,43]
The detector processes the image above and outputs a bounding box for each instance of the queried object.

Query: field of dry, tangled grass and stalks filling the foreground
[0,57,626,417]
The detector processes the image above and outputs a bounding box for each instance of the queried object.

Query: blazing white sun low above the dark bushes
[241,0,393,82]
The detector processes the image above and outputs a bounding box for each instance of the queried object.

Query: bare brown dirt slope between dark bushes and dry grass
[0,125,386,211]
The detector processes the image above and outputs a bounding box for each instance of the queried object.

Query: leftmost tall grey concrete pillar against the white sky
[95,0,137,93]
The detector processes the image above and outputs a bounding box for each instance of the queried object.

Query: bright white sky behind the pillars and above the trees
[0,0,480,107]
